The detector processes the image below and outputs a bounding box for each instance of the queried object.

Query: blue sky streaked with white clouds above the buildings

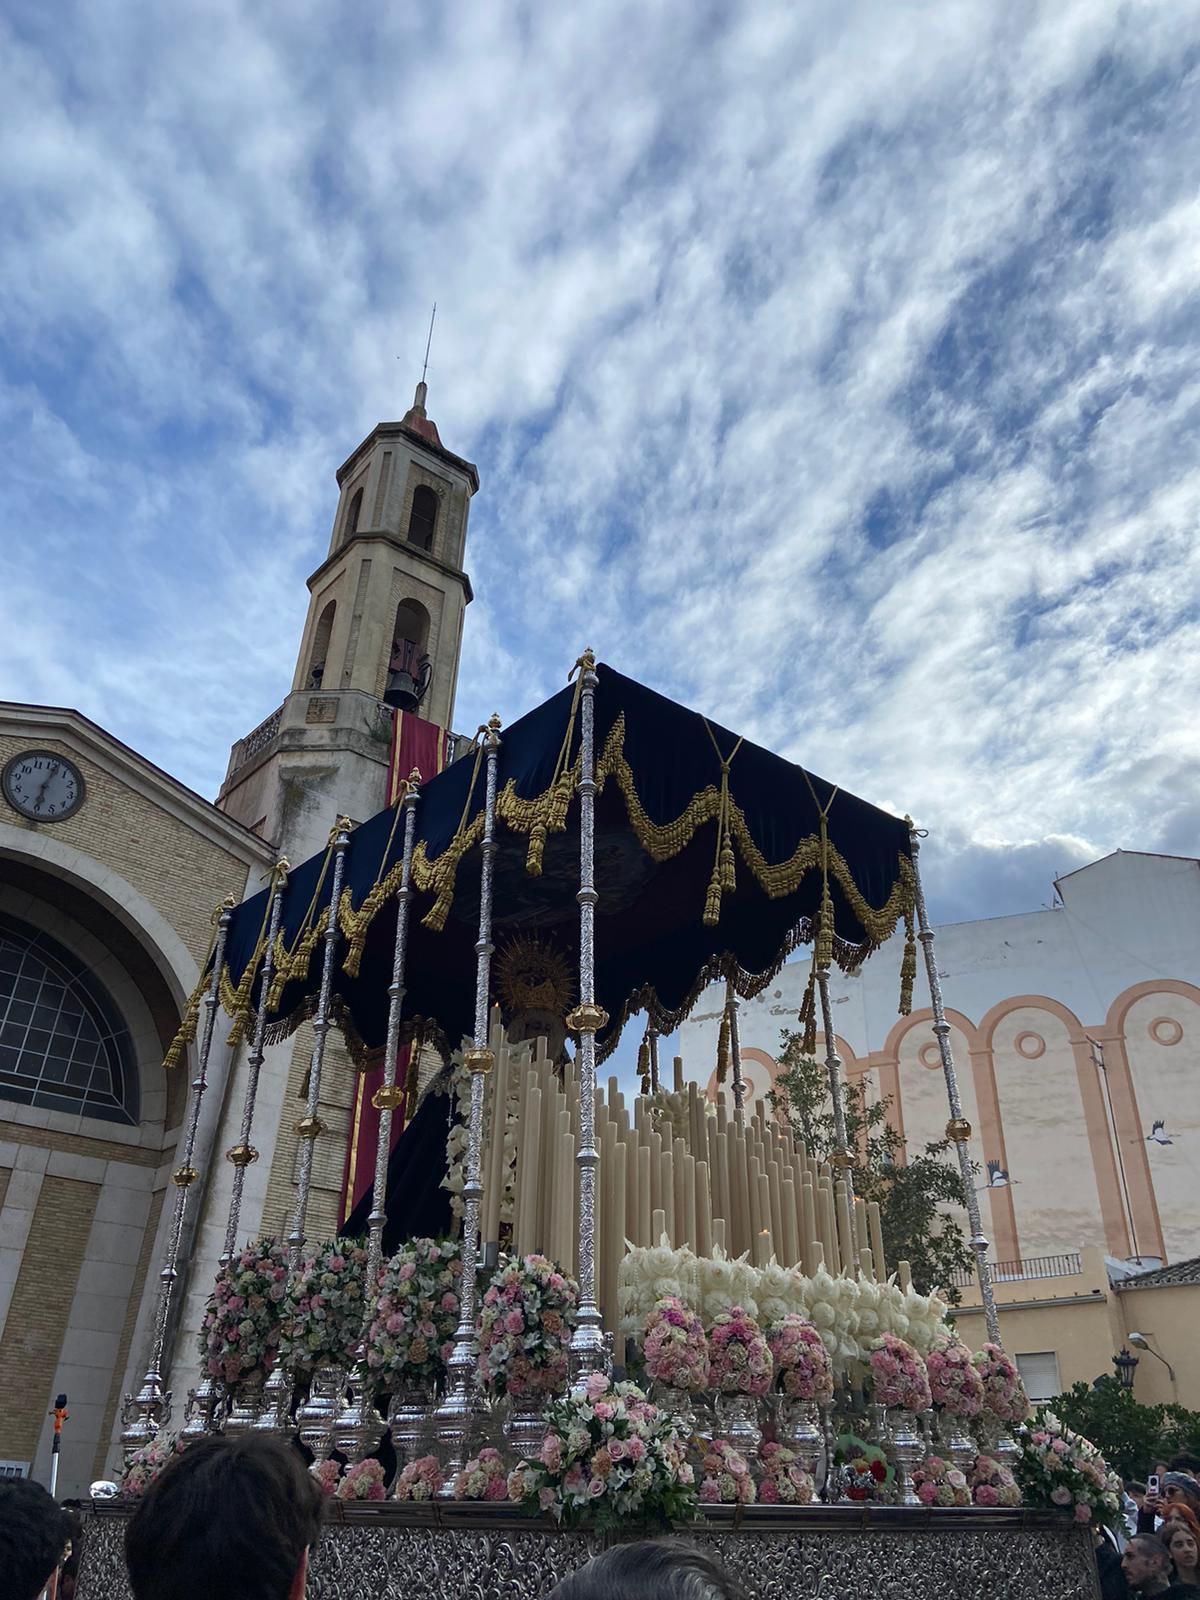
[0,0,1200,917]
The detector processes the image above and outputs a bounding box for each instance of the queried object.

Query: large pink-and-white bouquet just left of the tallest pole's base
[480,1256,579,1395]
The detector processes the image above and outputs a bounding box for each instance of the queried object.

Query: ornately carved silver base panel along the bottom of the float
[78,1502,1099,1600]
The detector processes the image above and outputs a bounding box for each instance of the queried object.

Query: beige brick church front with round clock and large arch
[0,704,269,1494]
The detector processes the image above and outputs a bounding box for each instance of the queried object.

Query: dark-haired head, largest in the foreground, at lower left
[125,1434,323,1600]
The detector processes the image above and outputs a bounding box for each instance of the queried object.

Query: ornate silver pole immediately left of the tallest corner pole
[434,715,501,1472]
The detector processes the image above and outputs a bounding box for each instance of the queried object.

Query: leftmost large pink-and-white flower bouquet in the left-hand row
[200,1237,288,1386]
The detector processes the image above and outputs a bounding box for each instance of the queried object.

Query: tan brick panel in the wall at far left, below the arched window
[0,1178,99,1461]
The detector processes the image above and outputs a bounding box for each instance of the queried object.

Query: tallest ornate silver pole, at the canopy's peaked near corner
[566,650,608,1382]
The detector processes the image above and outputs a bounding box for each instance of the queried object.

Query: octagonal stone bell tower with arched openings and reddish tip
[218,382,478,861]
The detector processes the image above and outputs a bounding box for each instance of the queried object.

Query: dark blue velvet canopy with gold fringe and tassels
[211,664,914,1059]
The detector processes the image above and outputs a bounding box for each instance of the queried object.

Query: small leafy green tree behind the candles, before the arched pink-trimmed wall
[768,1032,974,1304]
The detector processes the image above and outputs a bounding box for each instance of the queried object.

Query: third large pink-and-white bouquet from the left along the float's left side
[366,1238,462,1387]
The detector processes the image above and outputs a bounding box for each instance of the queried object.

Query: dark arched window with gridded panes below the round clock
[0,917,138,1128]
